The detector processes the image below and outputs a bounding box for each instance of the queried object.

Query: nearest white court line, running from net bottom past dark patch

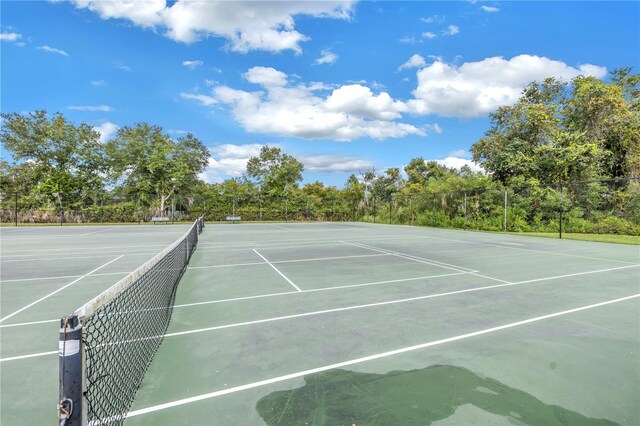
[126,294,640,418]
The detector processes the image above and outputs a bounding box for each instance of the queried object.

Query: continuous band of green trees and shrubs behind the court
[0,68,640,235]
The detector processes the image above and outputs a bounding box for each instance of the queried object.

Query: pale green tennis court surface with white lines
[0,223,640,425]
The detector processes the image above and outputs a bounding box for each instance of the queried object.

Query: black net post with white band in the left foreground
[58,315,83,426]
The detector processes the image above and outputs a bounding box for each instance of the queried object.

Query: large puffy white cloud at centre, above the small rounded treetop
[182,67,426,141]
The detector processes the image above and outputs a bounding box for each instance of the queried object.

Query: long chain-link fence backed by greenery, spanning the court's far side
[0,178,640,237]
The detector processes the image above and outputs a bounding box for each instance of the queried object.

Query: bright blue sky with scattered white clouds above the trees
[0,0,640,187]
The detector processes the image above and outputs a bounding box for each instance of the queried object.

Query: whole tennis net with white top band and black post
[58,218,204,426]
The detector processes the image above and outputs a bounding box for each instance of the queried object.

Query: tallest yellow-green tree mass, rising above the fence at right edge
[471,68,640,184]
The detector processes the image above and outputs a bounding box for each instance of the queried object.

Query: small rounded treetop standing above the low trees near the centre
[247,146,304,196]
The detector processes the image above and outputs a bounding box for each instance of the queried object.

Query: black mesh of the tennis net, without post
[83,219,204,424]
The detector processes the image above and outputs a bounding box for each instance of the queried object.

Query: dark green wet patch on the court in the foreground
[256,365,617,425]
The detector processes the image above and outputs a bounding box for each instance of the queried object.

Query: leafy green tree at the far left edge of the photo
[0,110,106,205]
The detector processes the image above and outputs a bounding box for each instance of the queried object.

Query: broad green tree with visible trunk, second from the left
[106,123,209,212]
